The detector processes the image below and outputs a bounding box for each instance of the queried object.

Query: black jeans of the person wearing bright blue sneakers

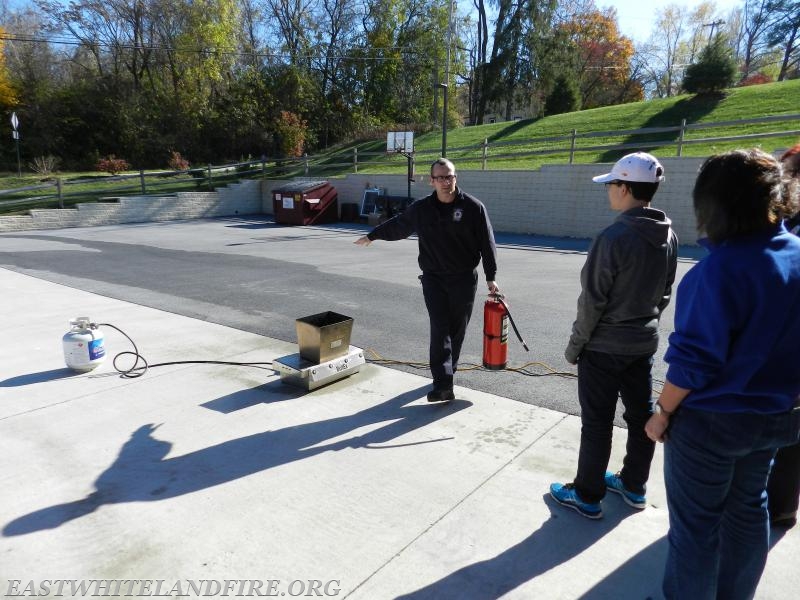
[574,350,656,502]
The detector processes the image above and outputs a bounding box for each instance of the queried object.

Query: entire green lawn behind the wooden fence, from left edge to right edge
[0,80,800,213]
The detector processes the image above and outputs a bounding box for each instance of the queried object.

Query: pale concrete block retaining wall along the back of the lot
[0,158,703,244]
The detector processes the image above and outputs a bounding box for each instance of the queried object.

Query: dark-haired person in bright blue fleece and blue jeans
[645,150,800,600]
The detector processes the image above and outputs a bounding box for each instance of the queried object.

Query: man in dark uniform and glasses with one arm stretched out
[355,158,499,402]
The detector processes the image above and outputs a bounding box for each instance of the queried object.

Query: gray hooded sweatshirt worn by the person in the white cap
[564,207,678,364]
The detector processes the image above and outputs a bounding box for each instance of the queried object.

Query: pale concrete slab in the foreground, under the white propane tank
[0,270,800,600]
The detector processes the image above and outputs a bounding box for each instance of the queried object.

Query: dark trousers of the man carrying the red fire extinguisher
[419,271,478,390]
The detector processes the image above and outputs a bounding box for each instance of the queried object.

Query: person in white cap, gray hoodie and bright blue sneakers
[550,152,678,519]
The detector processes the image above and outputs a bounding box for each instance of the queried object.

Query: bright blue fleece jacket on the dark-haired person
[664,224,800,413]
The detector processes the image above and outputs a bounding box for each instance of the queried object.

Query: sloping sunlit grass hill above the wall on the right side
[350,80,800,171]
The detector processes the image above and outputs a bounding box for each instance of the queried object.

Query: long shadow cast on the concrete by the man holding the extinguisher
[3,385,472,536]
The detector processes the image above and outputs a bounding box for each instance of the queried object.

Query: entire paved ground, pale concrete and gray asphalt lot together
[0,219,800,600]
